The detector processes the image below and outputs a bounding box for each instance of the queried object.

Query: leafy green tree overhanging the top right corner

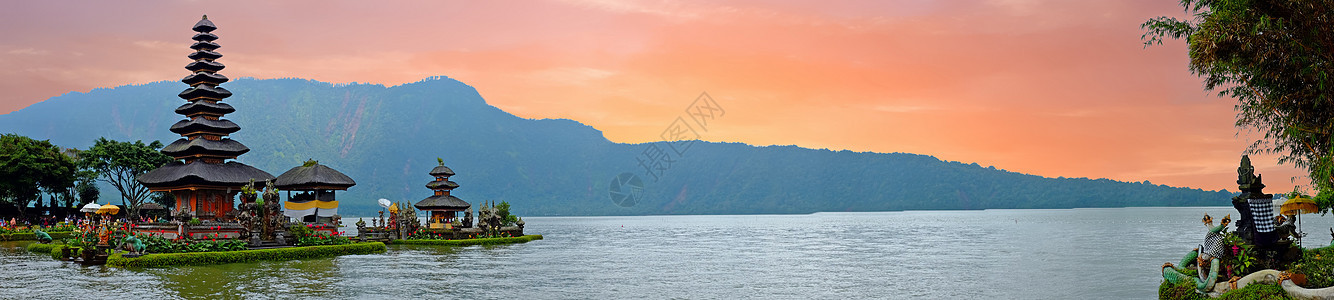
[1141,0,1334,193]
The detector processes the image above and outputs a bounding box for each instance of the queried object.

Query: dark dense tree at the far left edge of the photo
[0,133,75,216]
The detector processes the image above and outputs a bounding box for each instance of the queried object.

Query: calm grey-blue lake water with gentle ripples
[0,207,1334,299]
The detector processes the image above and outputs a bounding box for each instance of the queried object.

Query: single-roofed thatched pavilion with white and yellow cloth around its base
[273,160,356,223]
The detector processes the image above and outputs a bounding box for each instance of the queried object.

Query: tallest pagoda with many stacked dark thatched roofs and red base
[137,16,273,220]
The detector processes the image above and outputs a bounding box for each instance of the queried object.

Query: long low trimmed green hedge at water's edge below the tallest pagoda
[107,241,386,268]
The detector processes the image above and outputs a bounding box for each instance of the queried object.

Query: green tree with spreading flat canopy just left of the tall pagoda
[79,137,173,216]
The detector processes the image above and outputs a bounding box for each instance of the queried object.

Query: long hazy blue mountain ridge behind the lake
[0,77,1231,216]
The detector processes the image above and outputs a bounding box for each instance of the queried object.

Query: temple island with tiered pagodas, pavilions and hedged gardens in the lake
[29,16,542,267]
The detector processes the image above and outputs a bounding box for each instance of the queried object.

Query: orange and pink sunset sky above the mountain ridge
[0,0,1307,192]
